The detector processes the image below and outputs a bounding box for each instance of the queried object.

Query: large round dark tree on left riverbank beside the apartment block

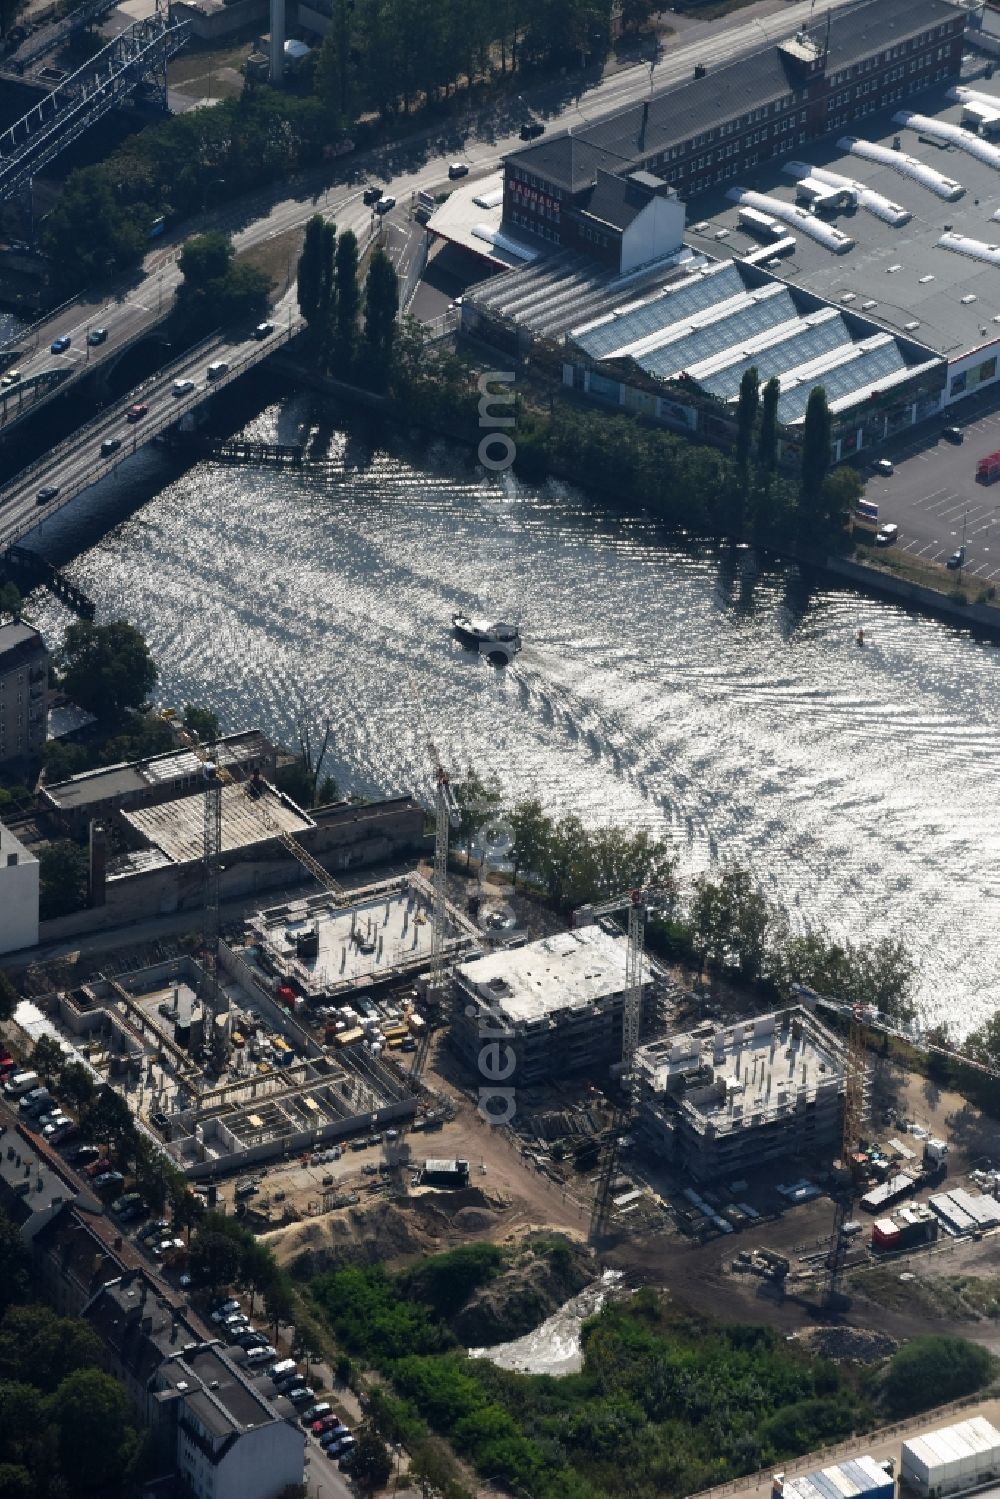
[58,619,159,724]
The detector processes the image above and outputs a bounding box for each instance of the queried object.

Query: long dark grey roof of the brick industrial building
[507,0,958,192]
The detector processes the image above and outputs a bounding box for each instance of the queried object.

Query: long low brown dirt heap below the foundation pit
[262,1187,508,1276]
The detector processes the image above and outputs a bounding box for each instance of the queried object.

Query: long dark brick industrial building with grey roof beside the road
[504,0,967,270]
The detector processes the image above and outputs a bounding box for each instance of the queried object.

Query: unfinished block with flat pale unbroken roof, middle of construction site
[451,922,660,1087]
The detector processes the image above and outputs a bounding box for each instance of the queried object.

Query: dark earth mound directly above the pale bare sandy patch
[451,1240,597,1348]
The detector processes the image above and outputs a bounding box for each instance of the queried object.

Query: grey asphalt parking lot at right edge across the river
[865,390,1000,583]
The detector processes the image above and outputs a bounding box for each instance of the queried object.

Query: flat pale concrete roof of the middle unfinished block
[456,923,652,1025]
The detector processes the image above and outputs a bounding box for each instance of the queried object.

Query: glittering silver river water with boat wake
[21,399,1000,1030]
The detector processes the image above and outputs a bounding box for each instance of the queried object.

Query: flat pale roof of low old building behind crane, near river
[121,764,313,863]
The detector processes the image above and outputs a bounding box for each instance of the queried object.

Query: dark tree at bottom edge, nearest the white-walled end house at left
[48,1369,138,1493]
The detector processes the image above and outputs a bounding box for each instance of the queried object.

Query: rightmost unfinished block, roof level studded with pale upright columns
[636,1006,846,1181]
